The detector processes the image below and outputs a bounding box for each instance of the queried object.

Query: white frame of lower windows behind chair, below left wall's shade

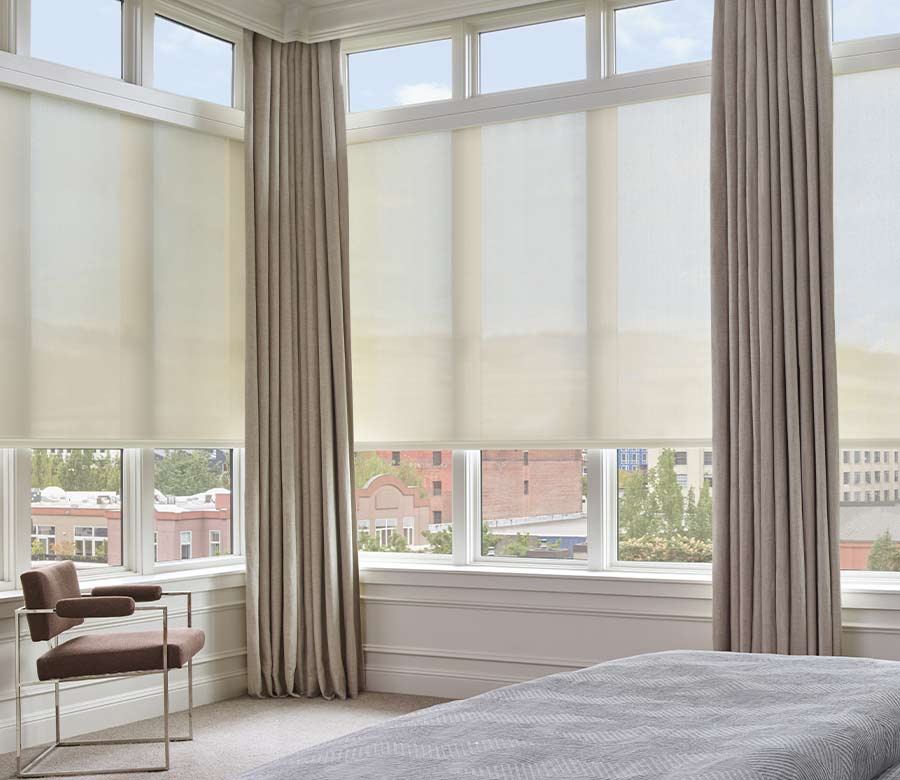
[0,443,244,591]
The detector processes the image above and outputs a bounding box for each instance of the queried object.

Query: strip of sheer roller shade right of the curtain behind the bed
[834,68,900,442]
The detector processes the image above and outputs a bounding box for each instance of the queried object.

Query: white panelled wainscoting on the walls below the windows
[0,567,900,752]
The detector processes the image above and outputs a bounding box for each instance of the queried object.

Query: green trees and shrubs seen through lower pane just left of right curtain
[617,449,712,563]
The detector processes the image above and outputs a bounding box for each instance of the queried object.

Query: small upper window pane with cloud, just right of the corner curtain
[347,39,453,112]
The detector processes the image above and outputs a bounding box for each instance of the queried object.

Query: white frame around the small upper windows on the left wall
[0,0,244,141]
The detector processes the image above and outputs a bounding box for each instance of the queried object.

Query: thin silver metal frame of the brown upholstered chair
[15,591,194,777]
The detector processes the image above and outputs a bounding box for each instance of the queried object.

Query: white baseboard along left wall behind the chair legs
[0,669,247,753]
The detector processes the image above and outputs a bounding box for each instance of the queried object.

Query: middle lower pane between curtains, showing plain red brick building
[481,450,588,560]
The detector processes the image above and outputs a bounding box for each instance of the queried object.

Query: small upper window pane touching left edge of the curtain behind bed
[615,0,713,73]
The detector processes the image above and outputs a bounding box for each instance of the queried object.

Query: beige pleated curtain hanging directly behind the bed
[711,0,840,655]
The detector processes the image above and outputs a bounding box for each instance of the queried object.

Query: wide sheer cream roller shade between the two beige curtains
[350,95,711,449]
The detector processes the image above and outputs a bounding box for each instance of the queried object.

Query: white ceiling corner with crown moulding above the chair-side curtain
[197,0,539,42]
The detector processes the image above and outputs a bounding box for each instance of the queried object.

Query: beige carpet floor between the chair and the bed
[0,693,443,780]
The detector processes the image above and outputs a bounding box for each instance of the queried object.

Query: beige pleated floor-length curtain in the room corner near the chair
[245,34,363,698]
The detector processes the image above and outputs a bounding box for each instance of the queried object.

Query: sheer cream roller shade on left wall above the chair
[0,88,244,446]
